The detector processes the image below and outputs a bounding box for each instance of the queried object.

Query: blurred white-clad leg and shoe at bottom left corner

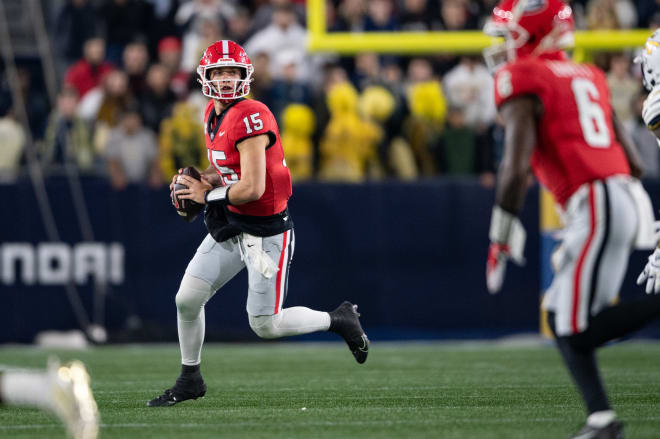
[0,360,99,439]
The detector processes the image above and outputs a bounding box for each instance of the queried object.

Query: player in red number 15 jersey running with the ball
[147,40,369,407]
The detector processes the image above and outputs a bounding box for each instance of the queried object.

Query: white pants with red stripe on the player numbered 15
[176,230,330,365]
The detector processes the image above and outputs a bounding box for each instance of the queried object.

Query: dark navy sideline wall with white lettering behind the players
[0,178,539,342]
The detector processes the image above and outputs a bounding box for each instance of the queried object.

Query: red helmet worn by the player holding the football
[197,40,254,101]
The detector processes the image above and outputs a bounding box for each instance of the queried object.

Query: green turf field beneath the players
[0,343,660,439]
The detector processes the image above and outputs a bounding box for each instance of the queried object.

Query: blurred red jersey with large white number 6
[495,52,630,205]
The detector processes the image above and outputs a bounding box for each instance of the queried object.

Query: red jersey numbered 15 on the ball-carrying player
[204,99,291,216]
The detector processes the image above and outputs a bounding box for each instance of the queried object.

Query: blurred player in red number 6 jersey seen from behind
[484,0,660,439]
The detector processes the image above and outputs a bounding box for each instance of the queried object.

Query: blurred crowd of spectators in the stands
[0,0,660,190]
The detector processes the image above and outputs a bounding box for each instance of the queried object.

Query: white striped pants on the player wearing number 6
[543,177,638,336]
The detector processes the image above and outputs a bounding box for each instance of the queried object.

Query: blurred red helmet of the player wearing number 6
[484,0,574,71]
